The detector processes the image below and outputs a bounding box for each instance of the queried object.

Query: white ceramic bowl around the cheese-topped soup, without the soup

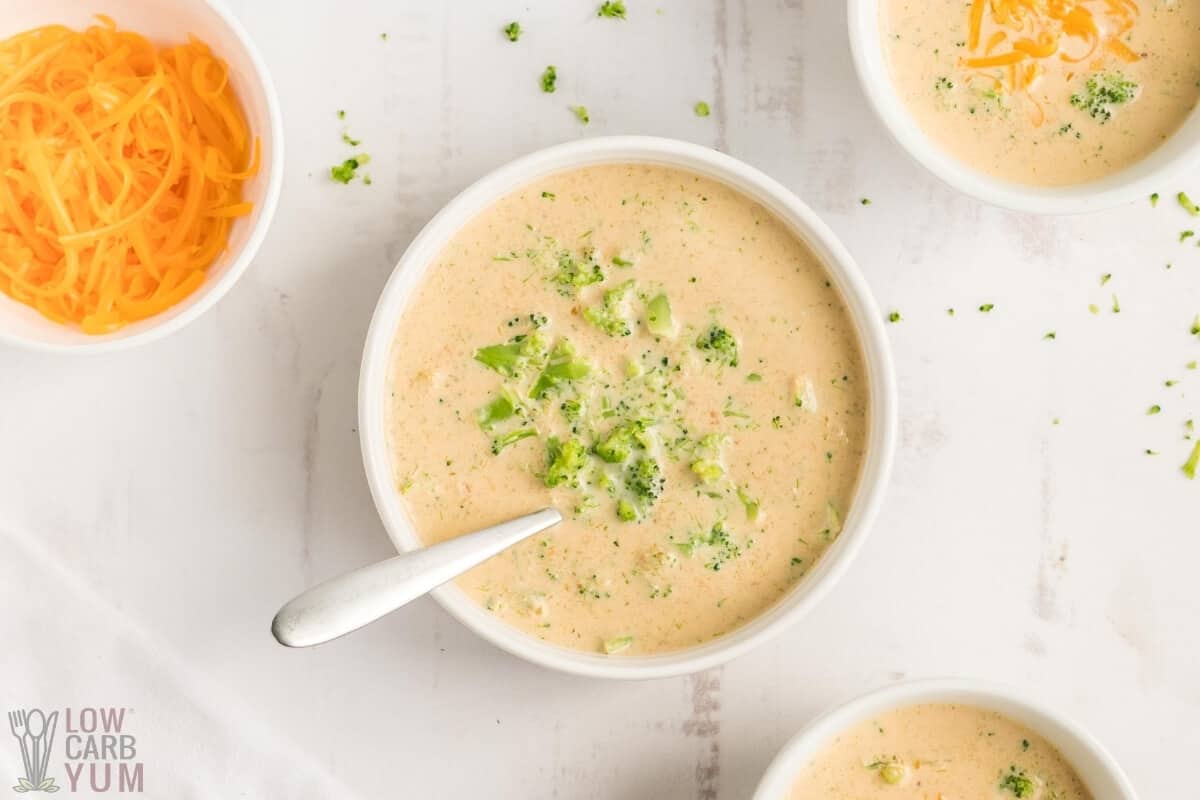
[847,0,1200,213]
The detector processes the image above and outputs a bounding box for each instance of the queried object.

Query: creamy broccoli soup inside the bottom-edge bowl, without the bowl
[791,704,1092,800]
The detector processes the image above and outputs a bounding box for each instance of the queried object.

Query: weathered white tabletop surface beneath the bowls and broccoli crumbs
[0,0,1200,800]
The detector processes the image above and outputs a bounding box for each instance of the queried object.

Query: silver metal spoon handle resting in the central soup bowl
[271,509,563,648]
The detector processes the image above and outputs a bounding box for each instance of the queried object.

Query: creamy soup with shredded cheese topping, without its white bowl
[880,0,1200,186]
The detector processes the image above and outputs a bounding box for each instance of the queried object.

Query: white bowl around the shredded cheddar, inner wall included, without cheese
[0,0,283,353]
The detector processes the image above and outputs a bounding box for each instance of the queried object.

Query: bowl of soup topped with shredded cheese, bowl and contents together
[848,0,1200,213]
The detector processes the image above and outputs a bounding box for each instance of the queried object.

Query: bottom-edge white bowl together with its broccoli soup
[754,679,1136,800]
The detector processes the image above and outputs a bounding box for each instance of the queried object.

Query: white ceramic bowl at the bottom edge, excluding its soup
[754,678,1138,800]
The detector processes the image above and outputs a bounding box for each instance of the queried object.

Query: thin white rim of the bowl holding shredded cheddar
[0,0,283,355]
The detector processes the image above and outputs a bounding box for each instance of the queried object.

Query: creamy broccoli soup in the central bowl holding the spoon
[388,164,869,655]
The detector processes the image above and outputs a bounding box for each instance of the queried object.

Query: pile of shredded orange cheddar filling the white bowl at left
[0,17,260,333]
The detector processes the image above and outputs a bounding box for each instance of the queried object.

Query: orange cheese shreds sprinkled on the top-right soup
[962,0,1141,122]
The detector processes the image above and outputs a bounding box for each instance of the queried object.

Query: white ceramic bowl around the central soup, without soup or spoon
[359,137,896,678]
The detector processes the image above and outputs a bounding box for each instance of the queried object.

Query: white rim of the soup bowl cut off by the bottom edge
[752,678,1138,800]
